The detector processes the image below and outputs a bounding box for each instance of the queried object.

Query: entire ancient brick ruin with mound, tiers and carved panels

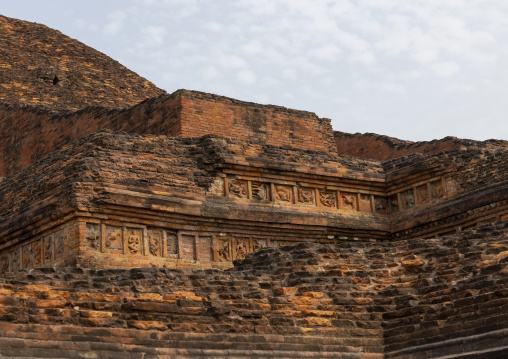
[0,17,508,359]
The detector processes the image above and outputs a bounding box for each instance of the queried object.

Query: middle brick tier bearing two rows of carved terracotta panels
[0,131,508,273]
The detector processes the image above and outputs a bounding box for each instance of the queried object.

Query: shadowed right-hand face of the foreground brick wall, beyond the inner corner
[383,222,508,359]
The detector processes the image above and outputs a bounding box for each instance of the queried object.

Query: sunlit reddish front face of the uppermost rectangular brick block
[181,91,335,153]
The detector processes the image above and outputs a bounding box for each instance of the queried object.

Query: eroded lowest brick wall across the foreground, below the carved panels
[0,222,508,359]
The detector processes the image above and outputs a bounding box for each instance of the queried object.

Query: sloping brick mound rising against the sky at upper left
[0,16,164,110]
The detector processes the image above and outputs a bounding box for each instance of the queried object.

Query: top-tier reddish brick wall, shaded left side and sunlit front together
[0,90,335,177]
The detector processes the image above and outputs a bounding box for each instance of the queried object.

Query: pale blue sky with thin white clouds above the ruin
[0,0,508,141]
